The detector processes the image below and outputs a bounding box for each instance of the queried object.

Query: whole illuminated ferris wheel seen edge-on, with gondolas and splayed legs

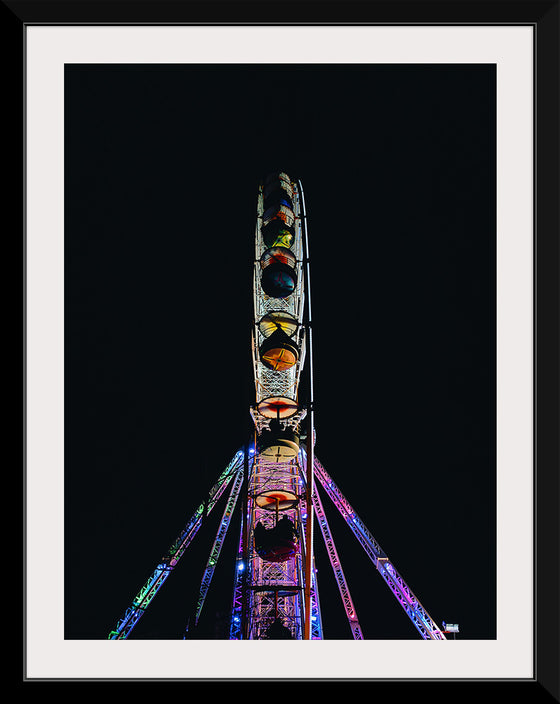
[108,172,452,640]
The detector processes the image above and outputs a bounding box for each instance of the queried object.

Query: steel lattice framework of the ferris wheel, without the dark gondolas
[109,174,445,640]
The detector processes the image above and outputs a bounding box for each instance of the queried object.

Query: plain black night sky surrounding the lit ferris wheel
[65,65,496,639]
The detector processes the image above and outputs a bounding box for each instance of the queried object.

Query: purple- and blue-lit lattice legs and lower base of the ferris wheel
[109,450,446,640]
